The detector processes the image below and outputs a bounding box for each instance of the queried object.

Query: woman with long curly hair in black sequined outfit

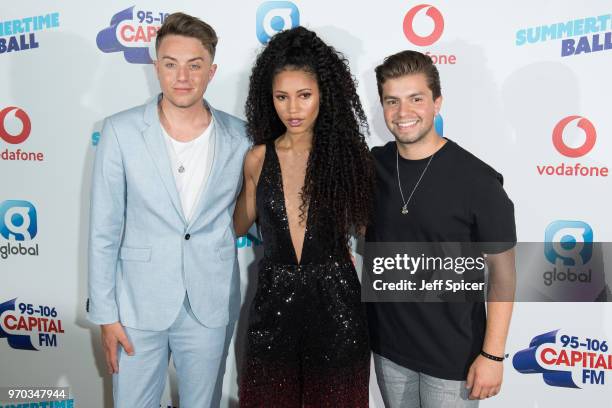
[234,27,373,408]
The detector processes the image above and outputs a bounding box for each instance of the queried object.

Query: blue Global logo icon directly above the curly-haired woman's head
[255,1,300,44]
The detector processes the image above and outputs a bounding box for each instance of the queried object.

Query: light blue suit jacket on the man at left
[88,98,250,330]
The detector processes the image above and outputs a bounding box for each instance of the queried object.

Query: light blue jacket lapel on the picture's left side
[142,97,185,223]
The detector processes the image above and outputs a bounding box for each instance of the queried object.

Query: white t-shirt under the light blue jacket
[162,117,214,222]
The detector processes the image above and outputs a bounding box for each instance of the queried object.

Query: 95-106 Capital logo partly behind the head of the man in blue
[96,6,168,64]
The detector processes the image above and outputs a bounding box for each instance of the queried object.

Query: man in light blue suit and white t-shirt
[88,13,249,408]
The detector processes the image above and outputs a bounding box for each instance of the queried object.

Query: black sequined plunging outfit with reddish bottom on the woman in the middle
[240,143,370,408]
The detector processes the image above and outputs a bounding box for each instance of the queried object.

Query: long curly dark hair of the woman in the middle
[245,27,374,246]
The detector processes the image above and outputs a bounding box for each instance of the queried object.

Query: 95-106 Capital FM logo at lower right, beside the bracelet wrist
[512,330,612,388]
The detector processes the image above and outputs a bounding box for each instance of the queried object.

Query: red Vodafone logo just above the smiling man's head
[402,4,457,65]
